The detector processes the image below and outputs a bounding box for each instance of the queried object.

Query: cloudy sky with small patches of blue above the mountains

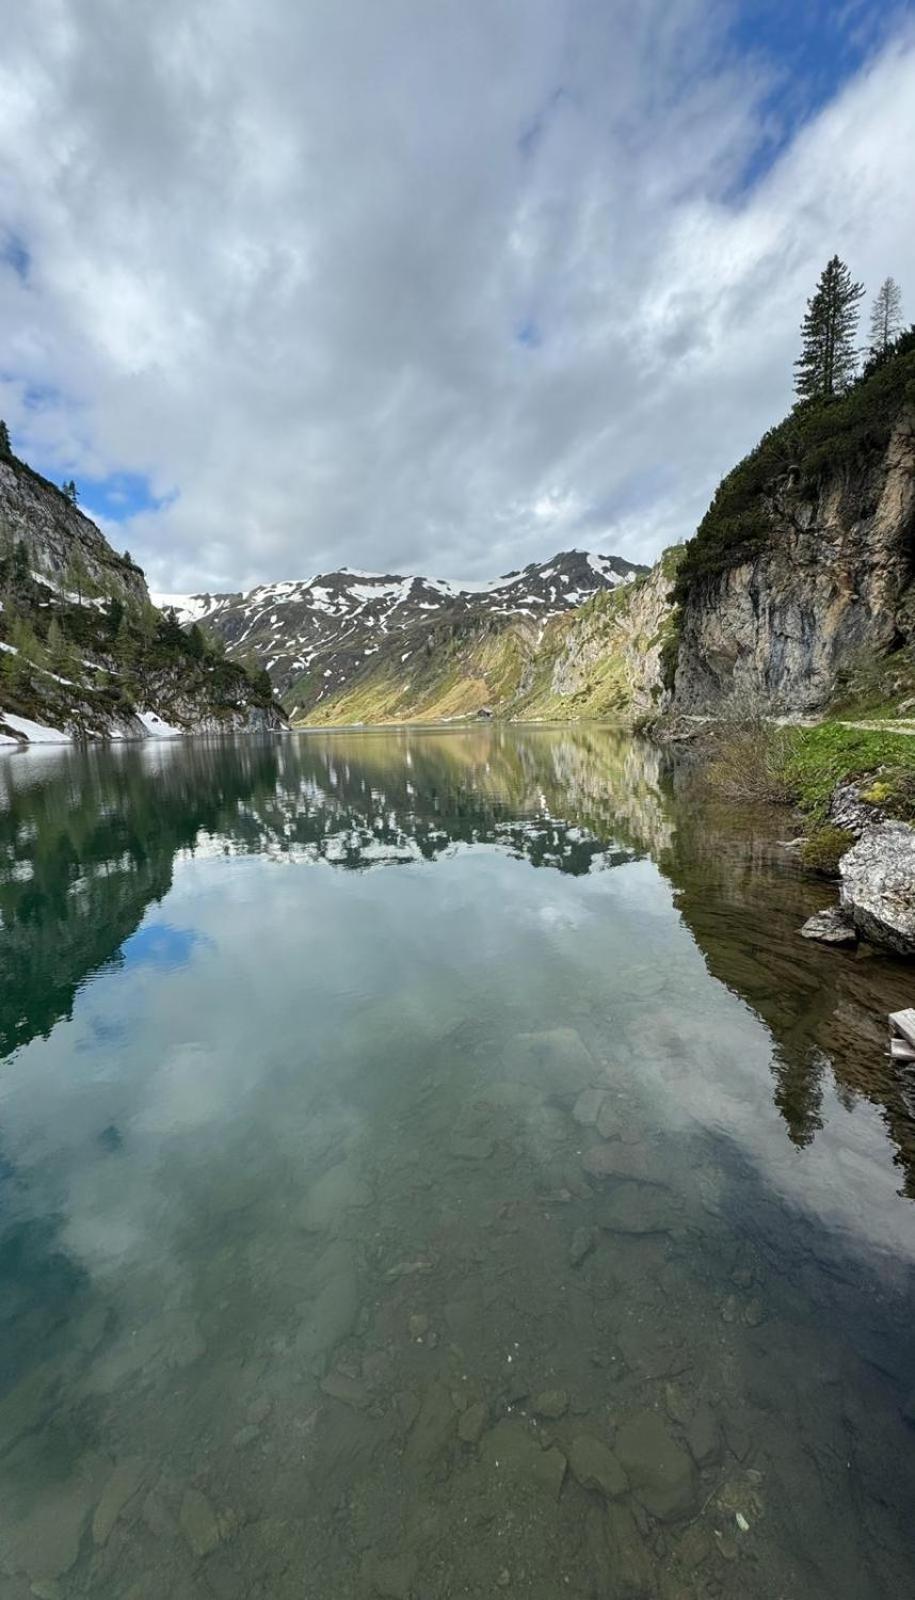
[0,0,915,592]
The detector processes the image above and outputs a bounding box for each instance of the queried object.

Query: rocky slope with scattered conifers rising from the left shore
[0,454,285,746]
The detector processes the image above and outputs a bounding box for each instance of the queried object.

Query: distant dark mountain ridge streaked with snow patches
[155,550,646,704]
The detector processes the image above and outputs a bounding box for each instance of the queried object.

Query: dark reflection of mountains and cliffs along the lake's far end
[0,726,915,1195]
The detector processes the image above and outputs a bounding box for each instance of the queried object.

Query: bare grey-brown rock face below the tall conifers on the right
[673,406,915,714]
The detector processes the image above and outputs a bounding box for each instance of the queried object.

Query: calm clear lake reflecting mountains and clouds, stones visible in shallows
[0,728,915,1600]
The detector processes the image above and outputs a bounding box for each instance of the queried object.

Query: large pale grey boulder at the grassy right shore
[838,822,915,955]
